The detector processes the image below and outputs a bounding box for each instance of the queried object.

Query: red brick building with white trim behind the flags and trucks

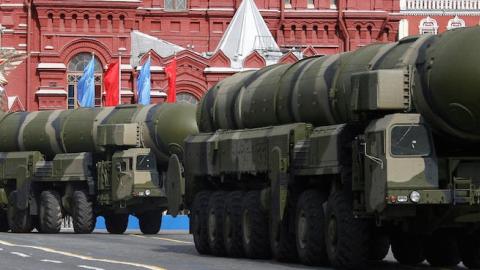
[0,0,401,110]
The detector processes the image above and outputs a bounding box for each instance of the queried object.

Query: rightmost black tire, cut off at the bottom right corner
[458,232,480,269]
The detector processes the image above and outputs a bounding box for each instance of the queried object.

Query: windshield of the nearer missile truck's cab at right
[392,125,431,156]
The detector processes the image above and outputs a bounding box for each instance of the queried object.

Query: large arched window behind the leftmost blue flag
[67,52,103,109]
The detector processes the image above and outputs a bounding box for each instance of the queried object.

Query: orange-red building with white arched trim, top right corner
[399,0,480,38]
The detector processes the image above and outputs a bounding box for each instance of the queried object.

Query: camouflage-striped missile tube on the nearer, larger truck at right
[197,27,480,141]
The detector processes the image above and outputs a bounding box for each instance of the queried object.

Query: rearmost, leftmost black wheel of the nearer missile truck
[191,191,211,254]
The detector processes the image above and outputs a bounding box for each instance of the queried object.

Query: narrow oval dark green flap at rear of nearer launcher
[165,154,185,217]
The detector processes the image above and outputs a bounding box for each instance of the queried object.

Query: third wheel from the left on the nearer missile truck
[223,191,244,258]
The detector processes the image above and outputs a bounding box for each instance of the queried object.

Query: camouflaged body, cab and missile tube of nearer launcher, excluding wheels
[183,27,480,236]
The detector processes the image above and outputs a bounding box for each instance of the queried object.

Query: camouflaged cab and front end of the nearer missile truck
[353,114,480,221]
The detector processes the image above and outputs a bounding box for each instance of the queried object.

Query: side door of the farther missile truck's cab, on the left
[112,154,133,201]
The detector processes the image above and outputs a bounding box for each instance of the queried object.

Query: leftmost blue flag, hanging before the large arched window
[77,56,95,108]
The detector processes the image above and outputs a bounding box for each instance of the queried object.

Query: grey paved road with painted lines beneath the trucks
[0,231,462,270]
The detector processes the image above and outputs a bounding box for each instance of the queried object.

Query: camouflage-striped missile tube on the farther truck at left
[0,104,197,162]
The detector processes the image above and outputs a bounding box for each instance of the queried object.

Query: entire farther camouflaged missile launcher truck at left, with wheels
[0,104,197,234]
